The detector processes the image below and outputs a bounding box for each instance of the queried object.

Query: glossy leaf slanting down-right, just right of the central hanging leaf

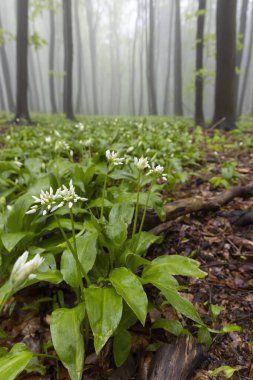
[109,268,148,325]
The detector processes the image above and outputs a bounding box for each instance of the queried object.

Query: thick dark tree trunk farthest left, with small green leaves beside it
[15,0,31,123]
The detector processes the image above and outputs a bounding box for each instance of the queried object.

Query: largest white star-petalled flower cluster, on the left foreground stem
[26,180,87,215]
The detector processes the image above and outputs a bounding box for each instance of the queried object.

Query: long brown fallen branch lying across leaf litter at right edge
[150,182,253,235]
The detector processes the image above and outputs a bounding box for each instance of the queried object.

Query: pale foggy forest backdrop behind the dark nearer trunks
[0,0,253,119]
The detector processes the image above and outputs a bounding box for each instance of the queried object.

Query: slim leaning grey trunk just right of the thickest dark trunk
[235,0,249,114]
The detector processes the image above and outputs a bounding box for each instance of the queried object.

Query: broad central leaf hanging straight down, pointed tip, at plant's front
[85,287,123,353]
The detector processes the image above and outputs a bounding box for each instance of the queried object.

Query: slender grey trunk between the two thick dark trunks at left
[49,10,57,113]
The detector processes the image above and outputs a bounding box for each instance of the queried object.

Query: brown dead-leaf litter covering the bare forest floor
[0,117,253,380]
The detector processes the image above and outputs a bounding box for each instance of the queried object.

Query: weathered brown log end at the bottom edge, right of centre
[149,336,207,380]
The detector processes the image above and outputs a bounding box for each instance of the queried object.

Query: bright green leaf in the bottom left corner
[0,343,33,380]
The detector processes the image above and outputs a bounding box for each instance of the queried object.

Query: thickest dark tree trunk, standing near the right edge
[213,0,236,130]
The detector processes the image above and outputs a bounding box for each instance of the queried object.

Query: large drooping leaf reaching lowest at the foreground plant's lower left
[50,304,85,380]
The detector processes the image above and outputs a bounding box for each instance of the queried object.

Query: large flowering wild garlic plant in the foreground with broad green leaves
[0,150,208,380]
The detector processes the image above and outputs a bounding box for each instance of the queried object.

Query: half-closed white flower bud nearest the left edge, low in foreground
[10,251,44,288]
